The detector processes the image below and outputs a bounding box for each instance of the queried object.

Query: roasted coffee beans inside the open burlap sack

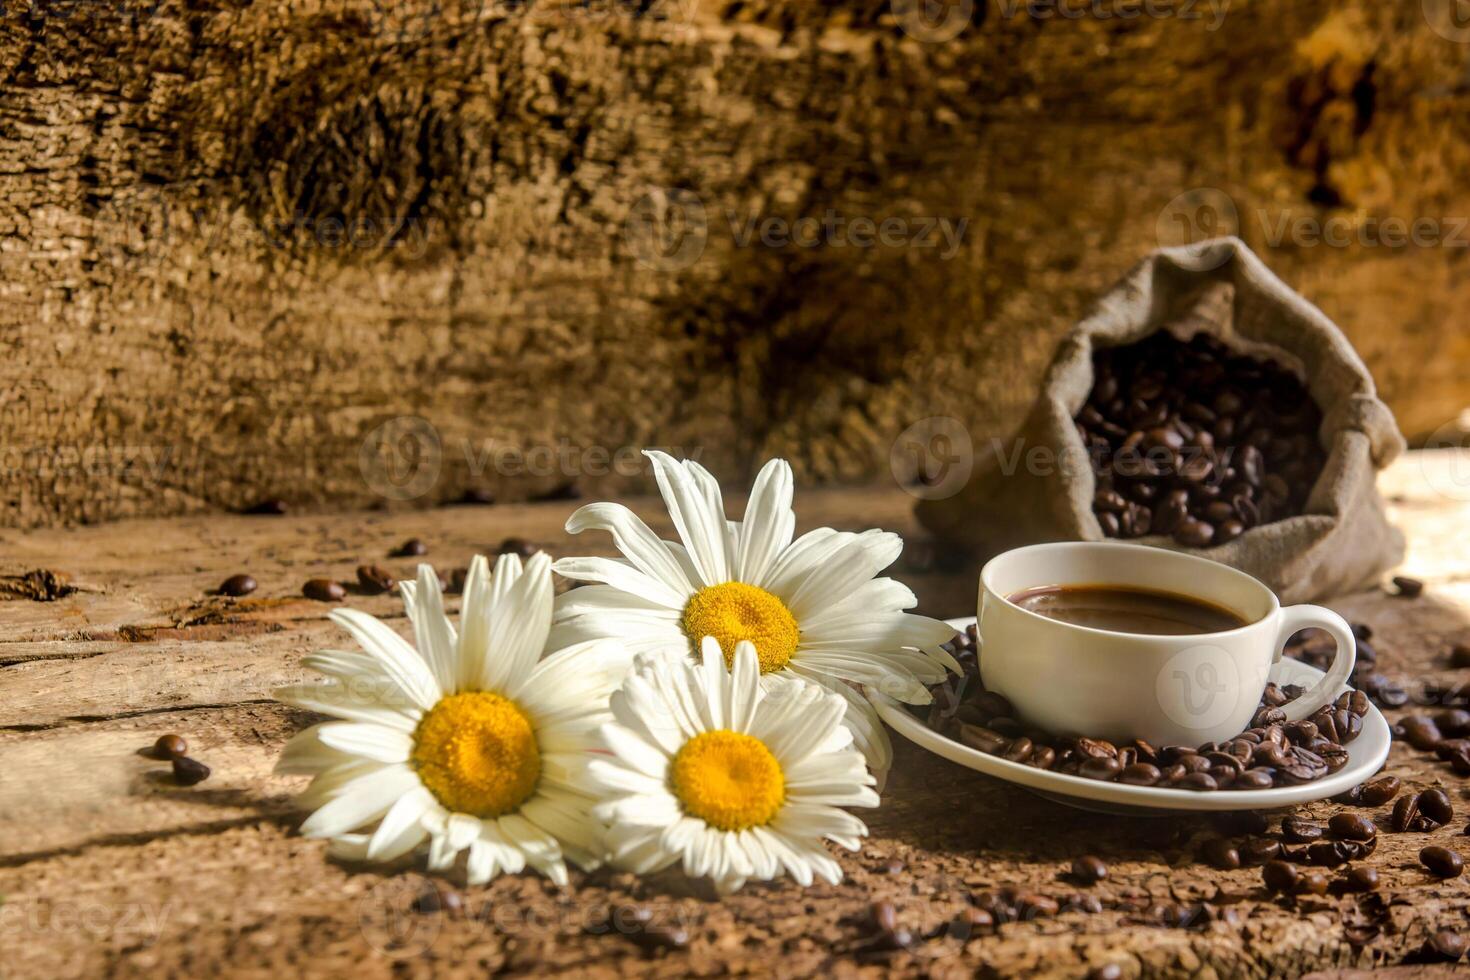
[1075,332,1326,548]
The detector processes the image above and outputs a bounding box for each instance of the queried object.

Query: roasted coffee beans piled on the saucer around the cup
[925,626,1369,792]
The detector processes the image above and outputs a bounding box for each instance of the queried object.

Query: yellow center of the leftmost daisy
[412,691,541,817]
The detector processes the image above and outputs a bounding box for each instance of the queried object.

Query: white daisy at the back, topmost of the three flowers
[554,451,960,773]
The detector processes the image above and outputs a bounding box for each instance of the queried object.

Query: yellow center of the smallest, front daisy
[669,729,786,830]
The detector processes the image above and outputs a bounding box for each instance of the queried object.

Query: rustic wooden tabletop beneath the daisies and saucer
[0,453,1470,979]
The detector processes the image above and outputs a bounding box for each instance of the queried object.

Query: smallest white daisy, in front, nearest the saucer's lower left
[589,638,878,892]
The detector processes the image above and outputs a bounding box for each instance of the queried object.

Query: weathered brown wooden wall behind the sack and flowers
[0,0,1470,526]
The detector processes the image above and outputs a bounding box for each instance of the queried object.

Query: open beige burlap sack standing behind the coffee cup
[919,238,1404,602]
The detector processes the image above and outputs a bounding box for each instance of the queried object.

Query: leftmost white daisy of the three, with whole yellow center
[275,554,622,884]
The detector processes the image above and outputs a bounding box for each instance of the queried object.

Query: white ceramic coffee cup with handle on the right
[979,541,1357,745]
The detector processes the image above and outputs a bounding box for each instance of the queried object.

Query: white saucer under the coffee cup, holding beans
[866,616,1391,814]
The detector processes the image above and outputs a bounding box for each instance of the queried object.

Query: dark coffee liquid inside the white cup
[1005,585,1247,636]
